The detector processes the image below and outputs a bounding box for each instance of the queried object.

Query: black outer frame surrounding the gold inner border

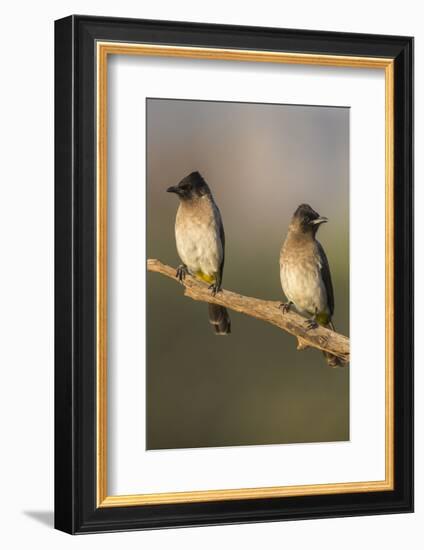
[55,15,413,534]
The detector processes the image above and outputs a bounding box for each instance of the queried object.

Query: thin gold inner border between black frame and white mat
[96,41,394,508]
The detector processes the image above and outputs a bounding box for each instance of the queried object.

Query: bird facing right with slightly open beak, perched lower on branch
[280,204,341,367]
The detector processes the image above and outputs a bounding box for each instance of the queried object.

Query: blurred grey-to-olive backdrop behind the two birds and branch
[146,99,349,449]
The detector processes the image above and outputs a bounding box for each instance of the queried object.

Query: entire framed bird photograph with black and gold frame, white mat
[55,16,413,534]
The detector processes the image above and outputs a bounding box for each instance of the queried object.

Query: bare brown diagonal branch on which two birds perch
[147,260,350,363]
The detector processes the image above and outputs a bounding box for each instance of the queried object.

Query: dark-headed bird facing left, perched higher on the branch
[167,172,231,335]
